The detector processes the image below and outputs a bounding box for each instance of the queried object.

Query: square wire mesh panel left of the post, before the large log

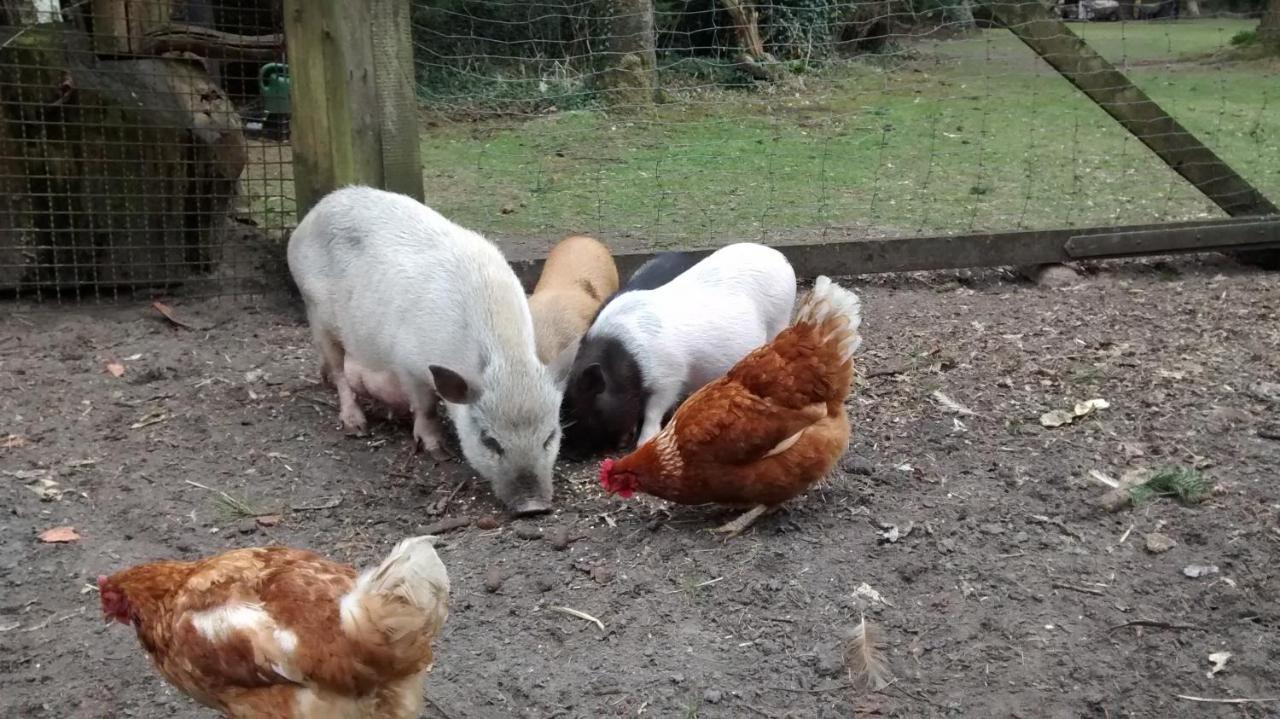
[0,0,293,299]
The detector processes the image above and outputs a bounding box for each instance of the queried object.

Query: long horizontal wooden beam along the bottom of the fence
[511,220,1280,290]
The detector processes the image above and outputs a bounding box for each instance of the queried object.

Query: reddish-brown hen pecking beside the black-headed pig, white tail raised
[600,276,861,536]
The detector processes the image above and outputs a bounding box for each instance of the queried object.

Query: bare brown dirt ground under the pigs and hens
[0,258,1280,719]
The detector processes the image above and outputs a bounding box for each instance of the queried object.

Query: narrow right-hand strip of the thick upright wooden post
[370,0,424,202]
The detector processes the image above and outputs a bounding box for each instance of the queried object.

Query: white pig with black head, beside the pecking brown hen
[564,242,796,449]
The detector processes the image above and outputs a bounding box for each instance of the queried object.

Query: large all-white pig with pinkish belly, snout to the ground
[288,187,572,513]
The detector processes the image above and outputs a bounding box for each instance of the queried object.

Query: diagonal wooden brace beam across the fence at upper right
[984,0,1280,217]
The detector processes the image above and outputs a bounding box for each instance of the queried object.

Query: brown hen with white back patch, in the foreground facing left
[99,536,449,719]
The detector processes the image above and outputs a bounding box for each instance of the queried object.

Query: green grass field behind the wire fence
[421,19,1280,247]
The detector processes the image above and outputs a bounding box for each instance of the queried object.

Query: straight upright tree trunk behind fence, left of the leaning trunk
[595,0,658,107]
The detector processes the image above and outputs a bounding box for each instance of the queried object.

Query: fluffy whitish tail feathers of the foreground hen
[340,535,449,641]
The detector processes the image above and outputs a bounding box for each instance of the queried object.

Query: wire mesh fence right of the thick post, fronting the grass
[413,0,1280,257]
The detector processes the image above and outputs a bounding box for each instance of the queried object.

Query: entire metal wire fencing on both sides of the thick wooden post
[0,0,1280,298]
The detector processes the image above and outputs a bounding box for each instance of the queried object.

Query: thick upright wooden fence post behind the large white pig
[284,0,422,219]
